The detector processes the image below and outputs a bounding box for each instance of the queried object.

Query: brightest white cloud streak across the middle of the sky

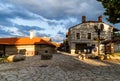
[8,13,77,36]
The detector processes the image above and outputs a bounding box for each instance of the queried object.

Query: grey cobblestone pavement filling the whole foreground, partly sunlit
[0,54,120,81]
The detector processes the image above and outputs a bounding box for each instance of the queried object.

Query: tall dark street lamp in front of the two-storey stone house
[94,24,104,55]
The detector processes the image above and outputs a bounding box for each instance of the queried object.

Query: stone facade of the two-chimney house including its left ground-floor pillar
[68,22,113,54]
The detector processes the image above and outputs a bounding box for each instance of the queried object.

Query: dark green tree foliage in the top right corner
[97,0,120,24]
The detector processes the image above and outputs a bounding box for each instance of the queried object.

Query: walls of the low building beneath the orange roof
[5,45,56,56]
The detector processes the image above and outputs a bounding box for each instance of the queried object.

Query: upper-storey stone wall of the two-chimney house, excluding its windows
[69,23,112,42]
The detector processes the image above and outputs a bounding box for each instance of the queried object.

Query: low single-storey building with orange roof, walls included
[0,37,56,56]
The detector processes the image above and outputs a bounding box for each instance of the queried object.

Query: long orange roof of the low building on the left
[0,37,55,46]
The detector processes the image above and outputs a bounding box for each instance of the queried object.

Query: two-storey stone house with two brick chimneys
[67,16,118,55]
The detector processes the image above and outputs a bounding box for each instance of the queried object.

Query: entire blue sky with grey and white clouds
[0,0,120,42]
